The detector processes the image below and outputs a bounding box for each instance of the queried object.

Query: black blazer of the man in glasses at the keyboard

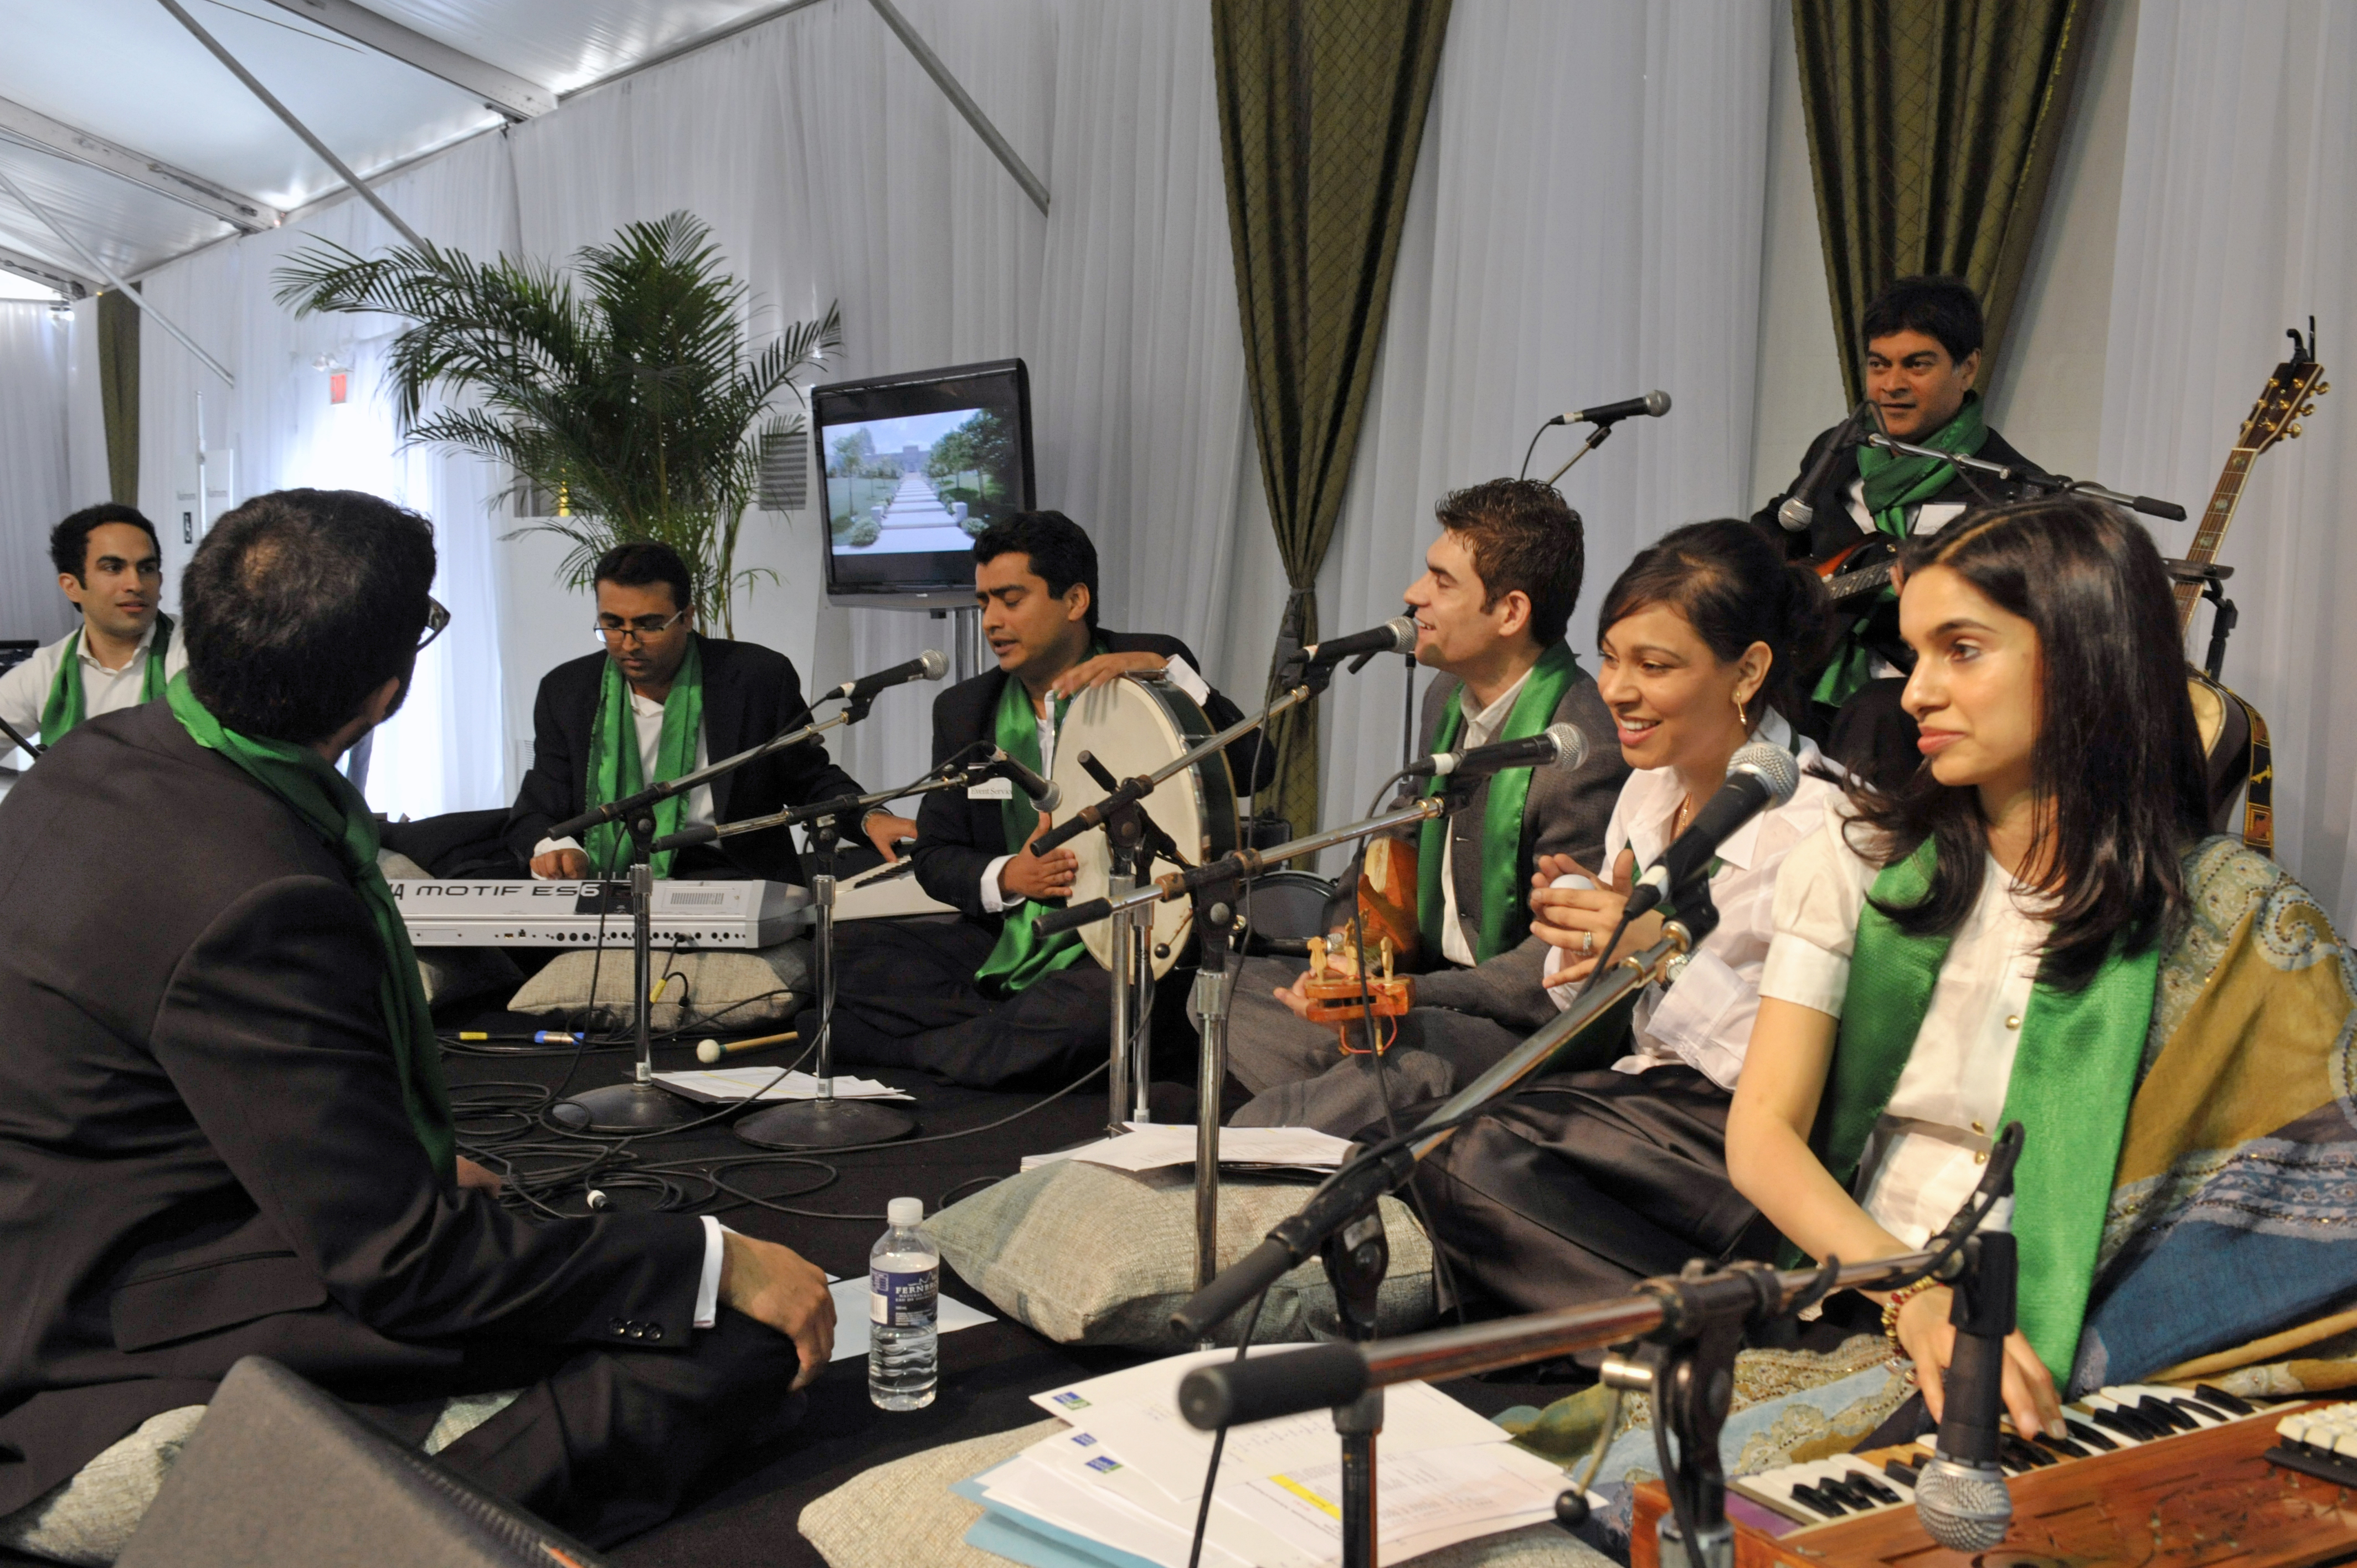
[507,635,865,882]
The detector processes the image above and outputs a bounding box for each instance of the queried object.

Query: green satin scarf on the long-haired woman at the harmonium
[1815,839,2162,1386]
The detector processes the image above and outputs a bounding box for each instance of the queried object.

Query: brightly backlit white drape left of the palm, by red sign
[139,137,516,818]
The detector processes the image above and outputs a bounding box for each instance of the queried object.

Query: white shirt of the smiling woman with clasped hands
[1546,714,1841,1089]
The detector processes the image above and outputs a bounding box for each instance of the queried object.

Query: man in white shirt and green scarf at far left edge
[0,502,188,750]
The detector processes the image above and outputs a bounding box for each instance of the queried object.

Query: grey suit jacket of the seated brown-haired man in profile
[1376,655,1629,1033]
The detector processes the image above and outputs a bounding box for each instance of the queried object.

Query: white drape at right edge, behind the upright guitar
[2102,0,2357,929]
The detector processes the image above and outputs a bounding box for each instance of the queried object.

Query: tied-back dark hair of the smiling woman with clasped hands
[1596,517,1834,724]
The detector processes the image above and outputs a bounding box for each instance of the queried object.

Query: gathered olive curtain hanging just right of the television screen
[1212,0,1449,832]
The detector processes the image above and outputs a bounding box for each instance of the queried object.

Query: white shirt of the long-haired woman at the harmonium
[1761,800,2051,1247]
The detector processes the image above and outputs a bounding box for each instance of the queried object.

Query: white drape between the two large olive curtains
[1310,0,1770,830]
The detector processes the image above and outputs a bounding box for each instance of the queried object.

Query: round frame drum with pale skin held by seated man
[1049,674,1237,978]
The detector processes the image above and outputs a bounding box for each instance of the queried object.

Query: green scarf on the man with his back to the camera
[165,674,457,1186]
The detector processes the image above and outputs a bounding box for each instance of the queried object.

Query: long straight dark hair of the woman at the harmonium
[1850,495,2209,991]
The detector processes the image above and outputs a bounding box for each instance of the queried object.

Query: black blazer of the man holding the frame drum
[910,632,1278,931]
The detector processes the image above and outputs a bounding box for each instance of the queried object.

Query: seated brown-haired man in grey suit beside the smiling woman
[1228,479,1629,1137]
